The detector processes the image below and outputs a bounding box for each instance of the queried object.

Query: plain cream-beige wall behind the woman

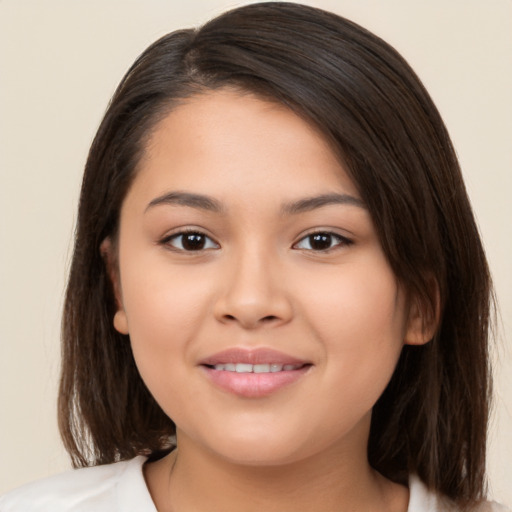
[0,0,512,506]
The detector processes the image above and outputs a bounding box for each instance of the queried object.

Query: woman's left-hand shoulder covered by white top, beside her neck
[0,457,156,512]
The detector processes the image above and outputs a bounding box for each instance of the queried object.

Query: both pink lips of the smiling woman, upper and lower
[200,348,312,398]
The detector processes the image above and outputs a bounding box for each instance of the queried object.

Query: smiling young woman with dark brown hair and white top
[0,3,508,512]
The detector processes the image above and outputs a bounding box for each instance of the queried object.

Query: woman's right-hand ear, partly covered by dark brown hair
[404,278,441,345]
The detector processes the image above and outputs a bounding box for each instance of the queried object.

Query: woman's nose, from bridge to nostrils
[214,248,293,330]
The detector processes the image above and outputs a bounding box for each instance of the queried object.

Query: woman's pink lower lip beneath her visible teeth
[202,366,311,398]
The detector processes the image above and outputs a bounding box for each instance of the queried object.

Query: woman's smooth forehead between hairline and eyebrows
[128,89,358,209]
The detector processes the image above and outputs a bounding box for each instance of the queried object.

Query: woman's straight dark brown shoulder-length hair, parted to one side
[59,2,492,504]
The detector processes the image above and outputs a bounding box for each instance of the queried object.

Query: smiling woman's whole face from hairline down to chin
[114,89,424,464]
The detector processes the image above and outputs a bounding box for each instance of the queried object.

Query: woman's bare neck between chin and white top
[145,428,408,512]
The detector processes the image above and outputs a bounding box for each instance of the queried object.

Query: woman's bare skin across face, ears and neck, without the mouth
[107,89,429,512]
